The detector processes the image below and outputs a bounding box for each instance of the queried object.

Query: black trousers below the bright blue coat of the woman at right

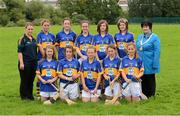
[141,74,156,98]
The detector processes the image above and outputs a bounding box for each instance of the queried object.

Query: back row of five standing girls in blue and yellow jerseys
[37,18,134,60]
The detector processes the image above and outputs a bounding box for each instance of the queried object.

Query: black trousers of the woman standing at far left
[18,63,37,100]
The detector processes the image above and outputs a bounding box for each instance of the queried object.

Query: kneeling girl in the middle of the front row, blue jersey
[81,46,102,102]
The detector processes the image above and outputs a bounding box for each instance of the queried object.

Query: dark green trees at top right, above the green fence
[128,0,180,17]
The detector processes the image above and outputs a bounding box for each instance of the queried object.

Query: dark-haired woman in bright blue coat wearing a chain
[136,21,160,98]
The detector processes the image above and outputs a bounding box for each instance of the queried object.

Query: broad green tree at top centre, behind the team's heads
[59,0,123,23]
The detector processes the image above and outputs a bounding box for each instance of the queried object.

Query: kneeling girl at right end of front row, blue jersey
[120,43,144,102]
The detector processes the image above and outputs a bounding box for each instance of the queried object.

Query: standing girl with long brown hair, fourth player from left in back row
[93,20,115,61]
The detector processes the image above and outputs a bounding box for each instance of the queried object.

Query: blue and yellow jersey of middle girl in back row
[75,34,93,56]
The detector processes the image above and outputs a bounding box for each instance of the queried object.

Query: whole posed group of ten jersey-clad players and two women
[17,18,160,105]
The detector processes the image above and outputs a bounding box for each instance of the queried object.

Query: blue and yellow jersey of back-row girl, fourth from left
[93,34,115,60]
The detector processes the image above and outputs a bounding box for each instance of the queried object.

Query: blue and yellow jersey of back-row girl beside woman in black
[37,31,56,60]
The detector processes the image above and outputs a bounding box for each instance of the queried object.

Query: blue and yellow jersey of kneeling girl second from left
[58,58,80,83]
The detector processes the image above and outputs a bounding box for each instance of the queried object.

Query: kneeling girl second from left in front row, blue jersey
[58,46,80,101]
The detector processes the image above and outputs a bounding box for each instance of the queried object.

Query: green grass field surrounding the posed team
[0,24,180,115]
